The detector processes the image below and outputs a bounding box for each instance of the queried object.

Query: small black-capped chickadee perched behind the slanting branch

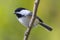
[15,8,52,31]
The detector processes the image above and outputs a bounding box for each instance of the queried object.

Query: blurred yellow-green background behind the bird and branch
[0,0,60,40]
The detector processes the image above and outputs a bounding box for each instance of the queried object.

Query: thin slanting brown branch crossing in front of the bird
[24,0,40,40]
